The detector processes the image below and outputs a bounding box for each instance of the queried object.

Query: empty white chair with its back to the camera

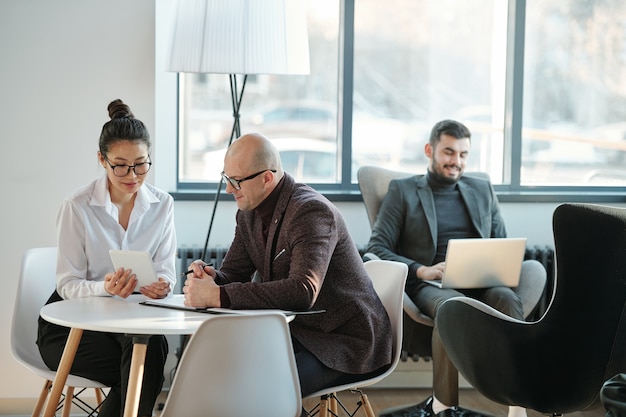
[161,312,302,417]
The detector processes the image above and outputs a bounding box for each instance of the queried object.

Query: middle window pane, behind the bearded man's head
[352,0,507,183]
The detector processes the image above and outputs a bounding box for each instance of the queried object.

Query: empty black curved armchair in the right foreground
[436,204,626,415]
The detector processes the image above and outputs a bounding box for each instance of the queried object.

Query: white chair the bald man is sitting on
[307,259,408,417]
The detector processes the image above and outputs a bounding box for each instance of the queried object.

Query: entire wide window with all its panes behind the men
[173,0,626,200]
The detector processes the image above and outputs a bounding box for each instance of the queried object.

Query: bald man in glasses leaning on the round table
[183,134,392,397]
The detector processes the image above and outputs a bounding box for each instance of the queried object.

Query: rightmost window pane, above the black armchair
[521,0,626,186]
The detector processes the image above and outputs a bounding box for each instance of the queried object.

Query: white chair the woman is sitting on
[11,247,107,417]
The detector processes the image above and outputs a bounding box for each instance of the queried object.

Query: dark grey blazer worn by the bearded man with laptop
[367,175,506,266]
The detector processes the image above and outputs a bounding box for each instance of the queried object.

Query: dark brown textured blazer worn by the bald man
[217,174,392,374]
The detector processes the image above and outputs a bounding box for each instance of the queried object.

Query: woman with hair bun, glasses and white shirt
[37,99,176,417]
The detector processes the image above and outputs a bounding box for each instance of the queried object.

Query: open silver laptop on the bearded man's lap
[424,238,526,289]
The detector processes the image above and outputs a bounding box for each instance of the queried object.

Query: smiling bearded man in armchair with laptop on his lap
[367,120,545,417]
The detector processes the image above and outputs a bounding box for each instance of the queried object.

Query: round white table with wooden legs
[40,295,213,417]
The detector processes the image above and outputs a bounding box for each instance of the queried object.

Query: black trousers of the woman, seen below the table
[37,318,168,417]
